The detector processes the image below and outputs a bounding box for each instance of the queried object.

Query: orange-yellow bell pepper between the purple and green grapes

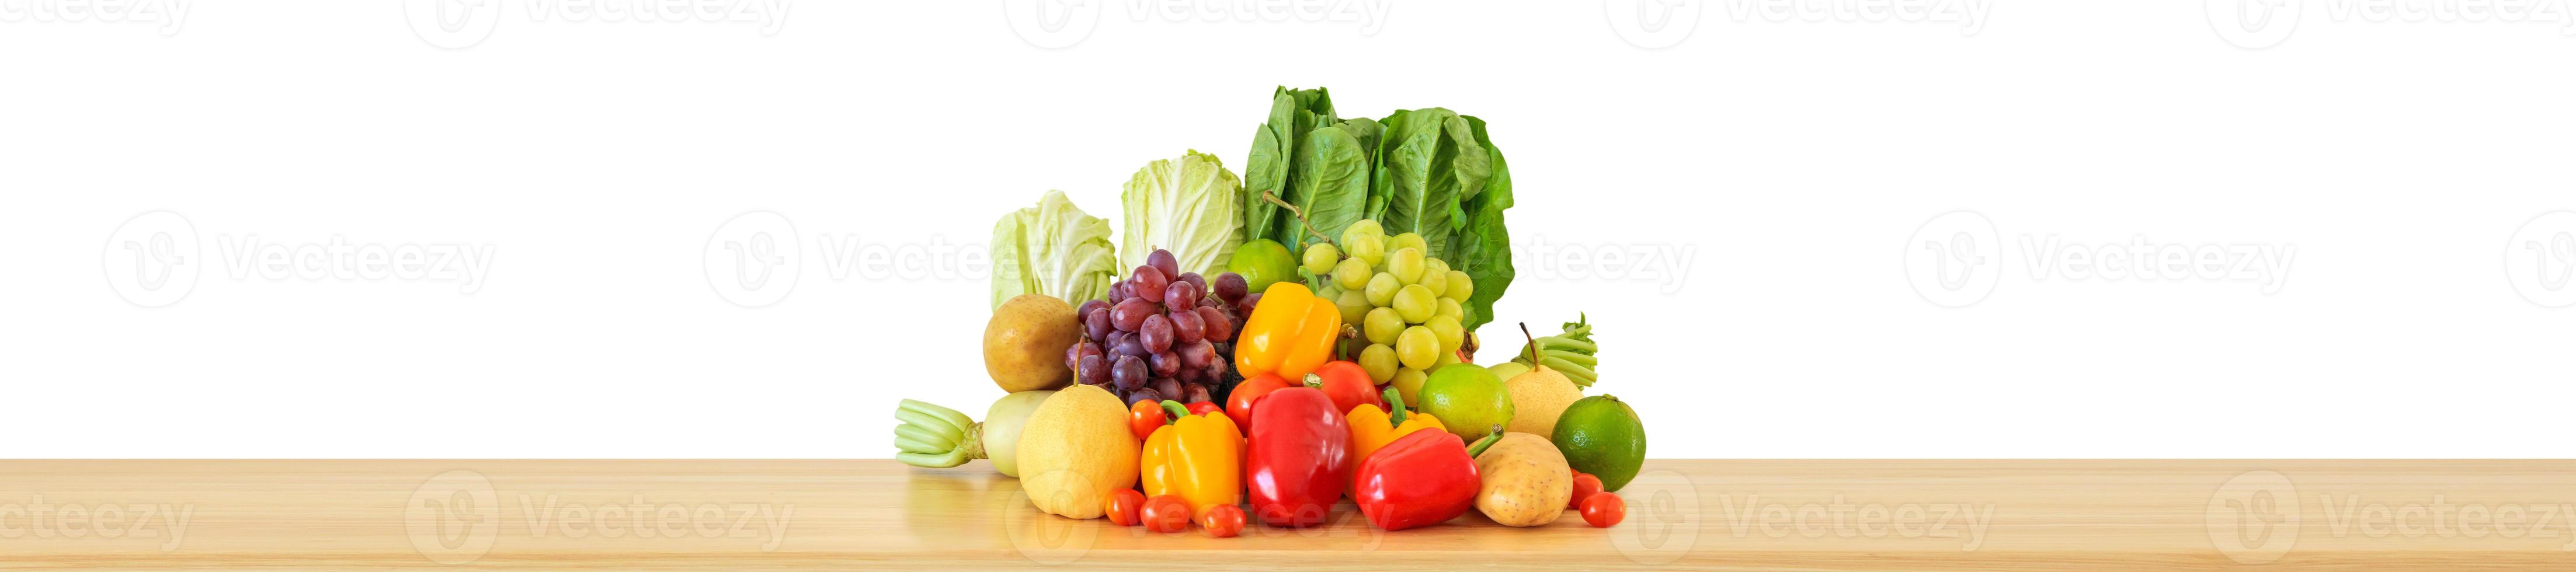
[1234,281,1342,379]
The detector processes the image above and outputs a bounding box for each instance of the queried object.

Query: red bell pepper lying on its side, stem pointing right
[1350,430,1502,531]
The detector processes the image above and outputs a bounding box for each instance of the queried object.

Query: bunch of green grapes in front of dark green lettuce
[1303,219,1476,394]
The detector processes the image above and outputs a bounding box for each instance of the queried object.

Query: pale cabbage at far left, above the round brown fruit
[992,191,1118,306]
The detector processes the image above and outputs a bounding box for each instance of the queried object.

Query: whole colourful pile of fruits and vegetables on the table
[894,88,1646,536]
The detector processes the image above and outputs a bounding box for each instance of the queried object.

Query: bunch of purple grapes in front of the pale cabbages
[1064,250,1262,404]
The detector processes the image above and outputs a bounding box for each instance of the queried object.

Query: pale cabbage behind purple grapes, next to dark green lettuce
[1118,149,1244,278]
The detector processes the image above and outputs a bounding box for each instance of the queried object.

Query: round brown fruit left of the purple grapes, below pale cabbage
[984,294,1082,392]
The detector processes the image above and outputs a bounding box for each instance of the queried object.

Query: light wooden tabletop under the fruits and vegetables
[0,461,2576,570]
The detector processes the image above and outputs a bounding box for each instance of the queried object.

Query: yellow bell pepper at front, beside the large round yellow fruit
[1139,409,1242,515]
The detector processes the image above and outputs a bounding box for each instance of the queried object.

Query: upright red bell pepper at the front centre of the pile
[1244,386,1353,528]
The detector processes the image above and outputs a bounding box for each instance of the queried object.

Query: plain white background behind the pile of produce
[0,0,2576,459]
